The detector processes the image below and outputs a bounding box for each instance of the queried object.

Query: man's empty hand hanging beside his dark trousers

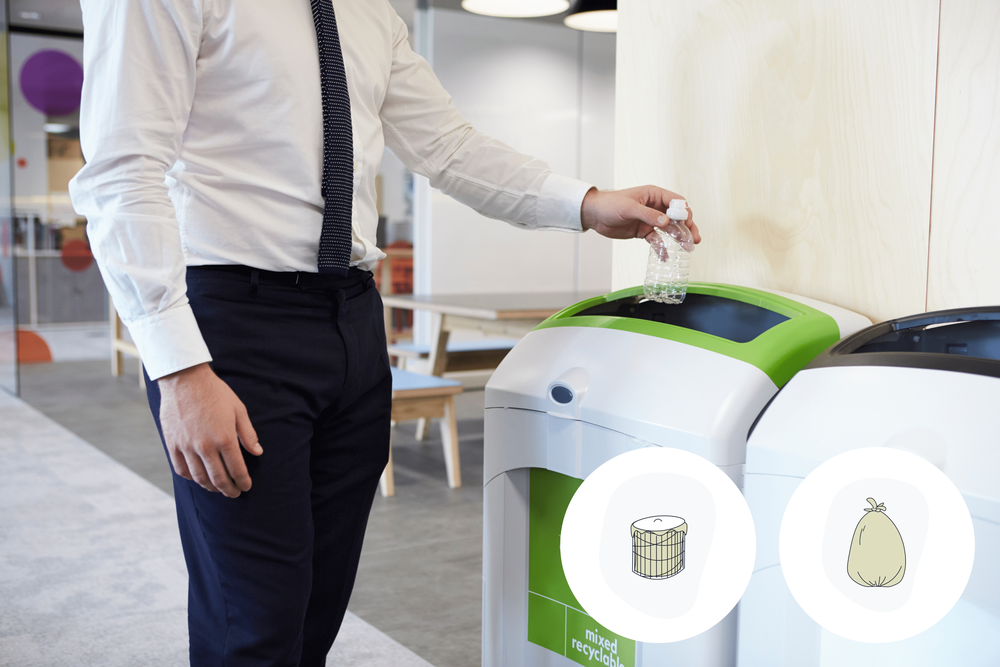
[157,364,264,498]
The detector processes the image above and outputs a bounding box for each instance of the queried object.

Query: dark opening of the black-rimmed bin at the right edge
[850,320,1000,360]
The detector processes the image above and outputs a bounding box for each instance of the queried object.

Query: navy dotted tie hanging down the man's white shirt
[312,0,354,276]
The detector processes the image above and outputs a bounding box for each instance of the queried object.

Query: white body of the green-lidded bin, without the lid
[483,327,777,667]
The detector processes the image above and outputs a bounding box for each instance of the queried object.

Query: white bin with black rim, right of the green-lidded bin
[738,307,1000,667]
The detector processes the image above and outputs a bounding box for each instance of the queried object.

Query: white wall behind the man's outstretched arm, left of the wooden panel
[414,9,615,314]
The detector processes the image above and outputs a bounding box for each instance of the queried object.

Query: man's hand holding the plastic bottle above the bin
[580,185,701,243]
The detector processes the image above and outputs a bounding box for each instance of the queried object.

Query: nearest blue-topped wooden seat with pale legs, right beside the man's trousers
[379,367,462,496]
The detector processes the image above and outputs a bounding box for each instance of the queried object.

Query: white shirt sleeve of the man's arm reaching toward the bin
[380,14,592,231]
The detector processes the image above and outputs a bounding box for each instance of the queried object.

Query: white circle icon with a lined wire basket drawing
[560,447,757,643]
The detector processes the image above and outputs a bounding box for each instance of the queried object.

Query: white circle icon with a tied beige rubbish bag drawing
[778,447,976,643]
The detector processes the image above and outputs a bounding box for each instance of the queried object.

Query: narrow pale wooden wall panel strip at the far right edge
[927,0,1000,310]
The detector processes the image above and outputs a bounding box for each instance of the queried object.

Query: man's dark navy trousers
[146,267,392,667]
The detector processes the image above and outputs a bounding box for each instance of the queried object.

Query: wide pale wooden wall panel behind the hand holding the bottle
[613,0,938,320]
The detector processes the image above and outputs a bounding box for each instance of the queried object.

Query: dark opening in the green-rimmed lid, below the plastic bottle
[572,292,789,343]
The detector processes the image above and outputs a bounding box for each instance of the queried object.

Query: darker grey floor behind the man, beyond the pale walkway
[13,361,483,667]
